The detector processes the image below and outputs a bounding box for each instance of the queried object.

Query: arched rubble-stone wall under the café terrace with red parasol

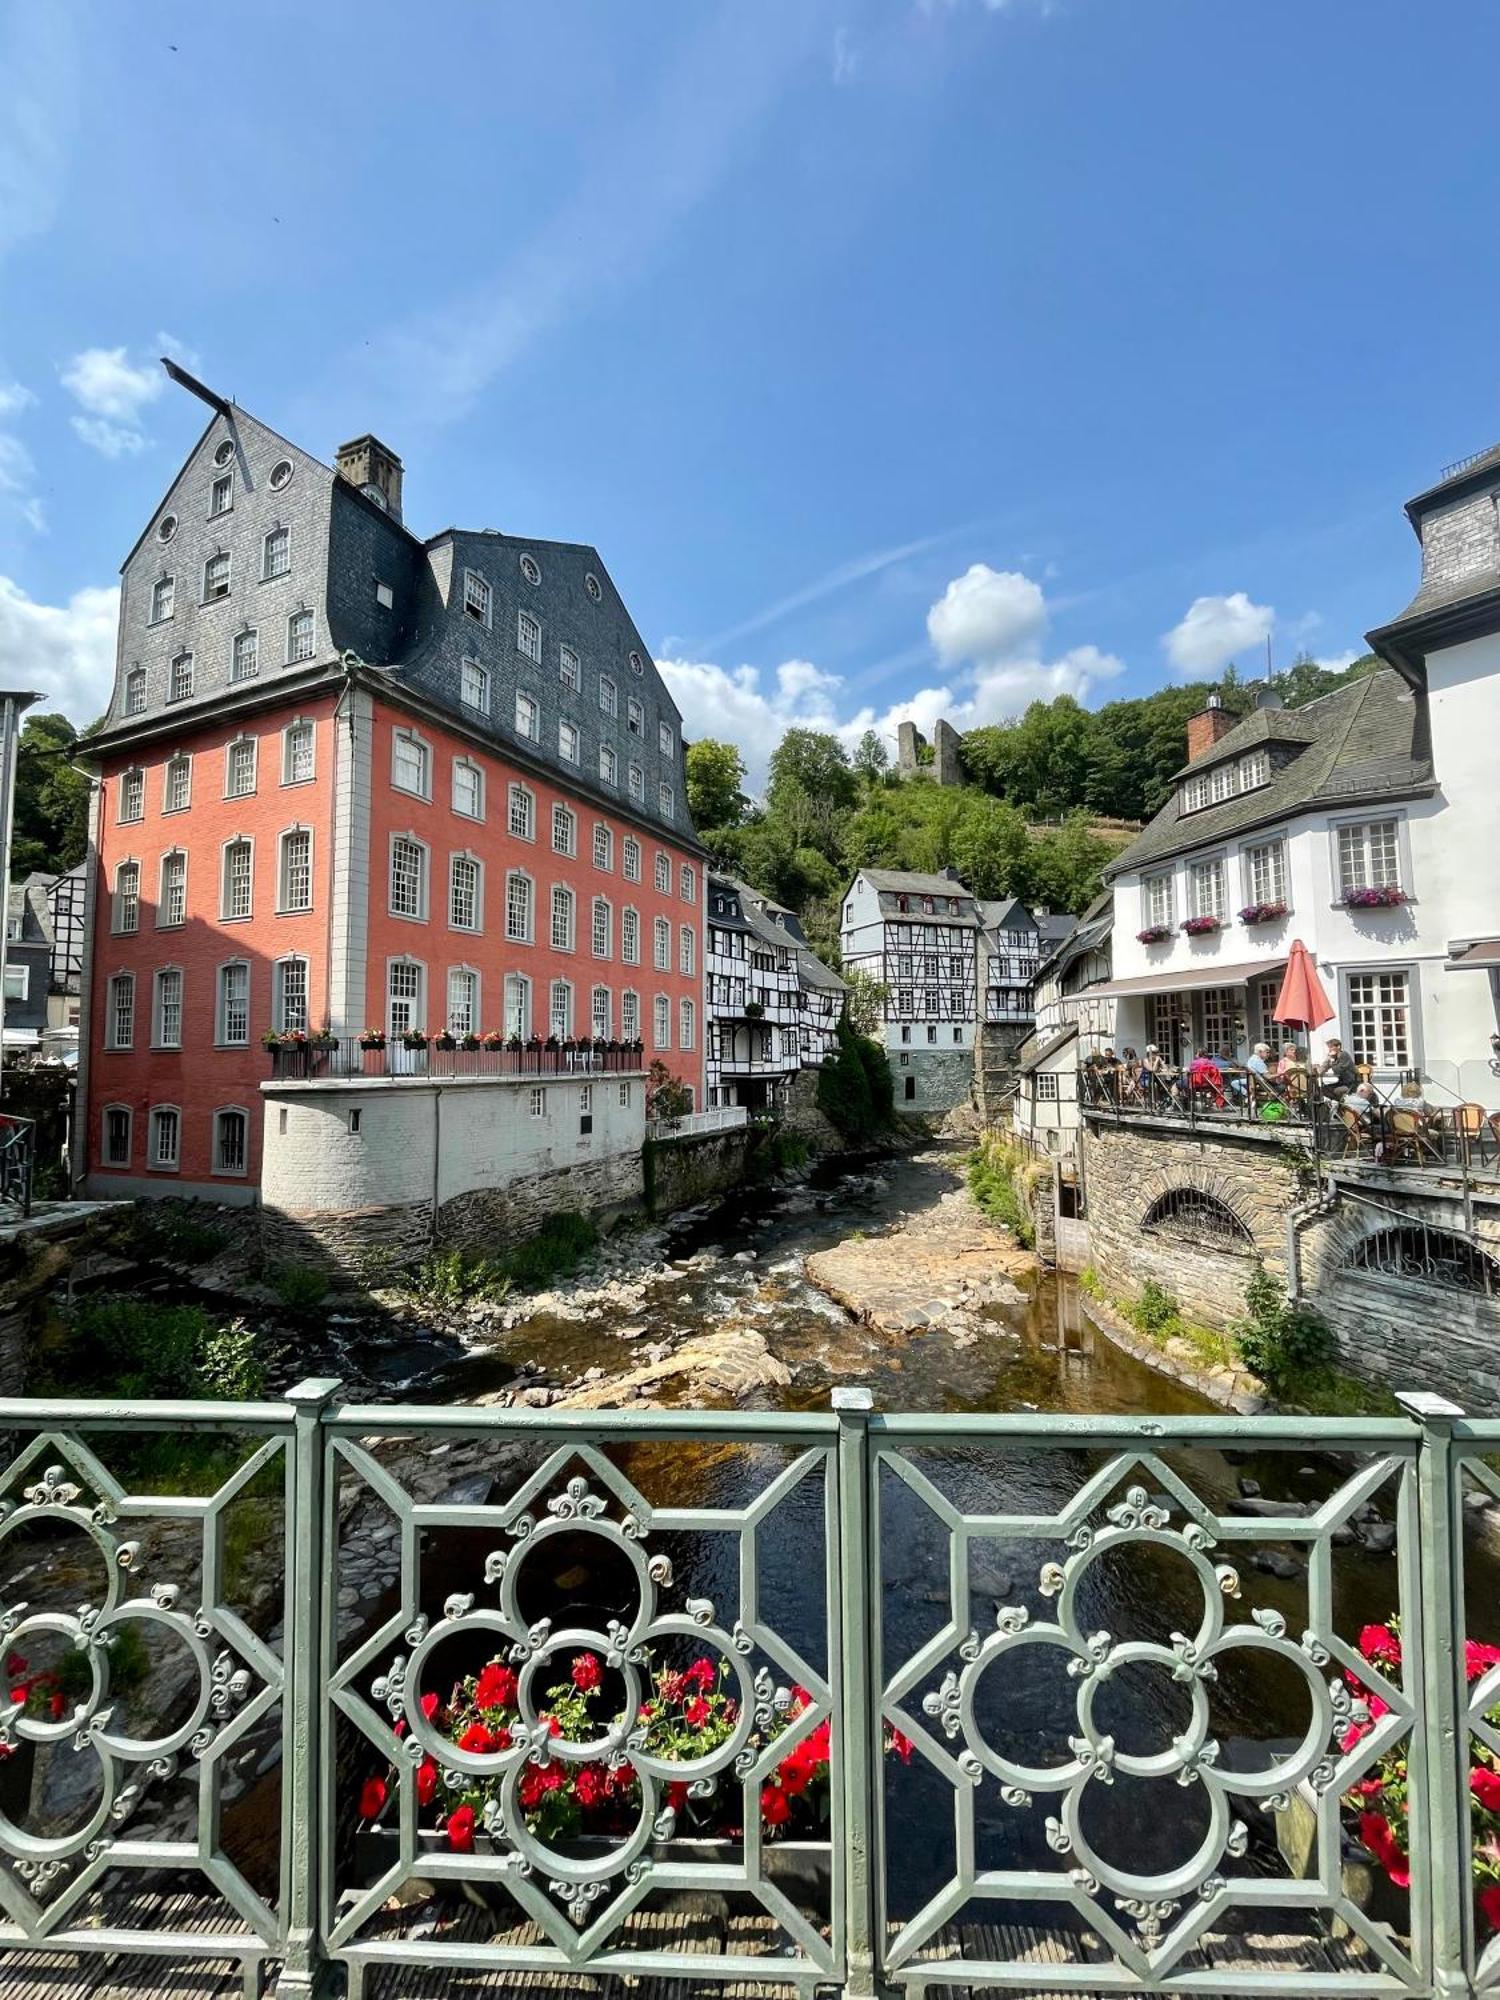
[1084,1118,1500,1414]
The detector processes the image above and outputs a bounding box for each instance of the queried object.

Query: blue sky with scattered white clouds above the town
[0,0,1500,774]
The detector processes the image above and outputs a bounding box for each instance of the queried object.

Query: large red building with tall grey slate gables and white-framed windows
[80,376,704,1206]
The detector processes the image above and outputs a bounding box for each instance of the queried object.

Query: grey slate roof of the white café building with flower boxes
[1104,668,1432,880]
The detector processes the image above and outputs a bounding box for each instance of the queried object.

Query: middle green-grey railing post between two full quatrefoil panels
[832,1388,882,2000]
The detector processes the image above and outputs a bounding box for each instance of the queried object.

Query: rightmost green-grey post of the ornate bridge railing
[1396,1390,1474,2000]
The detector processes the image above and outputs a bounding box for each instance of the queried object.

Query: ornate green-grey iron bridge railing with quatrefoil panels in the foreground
[0,1382,1500,2000]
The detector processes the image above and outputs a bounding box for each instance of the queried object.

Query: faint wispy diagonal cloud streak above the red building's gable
[348,0,832,422]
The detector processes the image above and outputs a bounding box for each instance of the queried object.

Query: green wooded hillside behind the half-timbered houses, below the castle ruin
[688,654,1380,962]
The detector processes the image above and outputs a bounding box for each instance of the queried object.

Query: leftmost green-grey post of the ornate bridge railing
[274,1378,340,2000]
